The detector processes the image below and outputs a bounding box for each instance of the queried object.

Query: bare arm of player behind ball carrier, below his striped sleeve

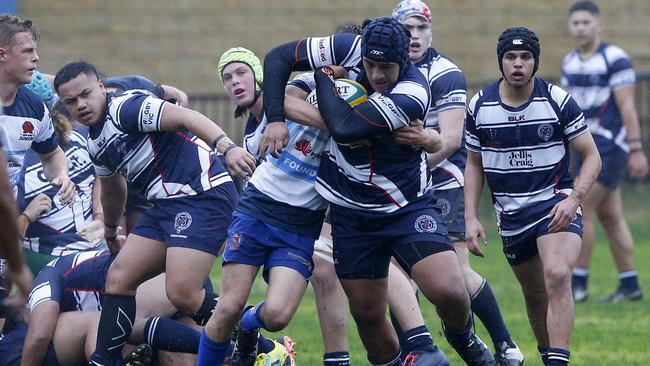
[427,108,465,166]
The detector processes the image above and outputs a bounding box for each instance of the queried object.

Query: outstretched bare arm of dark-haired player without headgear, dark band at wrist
[160,103,255,179]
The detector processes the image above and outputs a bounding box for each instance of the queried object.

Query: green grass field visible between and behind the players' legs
[214,185,650,366]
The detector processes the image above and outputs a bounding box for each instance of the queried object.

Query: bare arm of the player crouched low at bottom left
[20,300,59,366]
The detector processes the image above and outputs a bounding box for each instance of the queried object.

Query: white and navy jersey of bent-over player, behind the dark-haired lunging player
[17,127,100,256]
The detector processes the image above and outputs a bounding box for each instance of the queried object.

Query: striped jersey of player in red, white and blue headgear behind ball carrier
[415,48,467,190]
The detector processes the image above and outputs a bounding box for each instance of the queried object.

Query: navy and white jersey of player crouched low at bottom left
[29,250,116,313]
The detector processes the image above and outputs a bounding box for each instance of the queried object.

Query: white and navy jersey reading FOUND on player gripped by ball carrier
[237,75,329,237]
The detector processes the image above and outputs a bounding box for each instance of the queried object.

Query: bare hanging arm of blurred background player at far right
[613,84,650,179]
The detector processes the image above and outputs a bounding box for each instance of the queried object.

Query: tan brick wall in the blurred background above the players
[18,0,650,94]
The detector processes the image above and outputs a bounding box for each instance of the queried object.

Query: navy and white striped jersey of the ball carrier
[307,35,431,212]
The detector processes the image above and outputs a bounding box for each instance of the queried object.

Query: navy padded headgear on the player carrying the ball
[361,17,411,75]
